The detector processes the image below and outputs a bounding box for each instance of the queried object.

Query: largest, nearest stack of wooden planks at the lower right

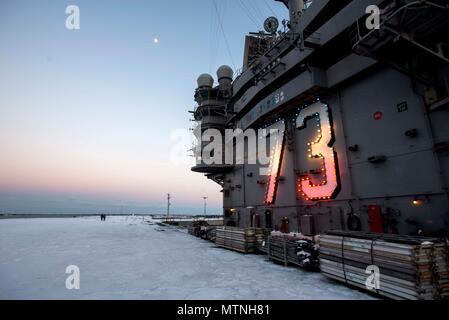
[320,231,449,300]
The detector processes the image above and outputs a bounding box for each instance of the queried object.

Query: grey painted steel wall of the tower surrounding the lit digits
[189,0,449,235]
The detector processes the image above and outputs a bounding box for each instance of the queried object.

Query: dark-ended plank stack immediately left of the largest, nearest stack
[260,232,319,271]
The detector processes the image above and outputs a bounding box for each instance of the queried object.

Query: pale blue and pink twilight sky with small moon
[0,0,288,213]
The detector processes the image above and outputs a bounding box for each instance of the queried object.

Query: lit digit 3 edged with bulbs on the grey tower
[296,102,340,200]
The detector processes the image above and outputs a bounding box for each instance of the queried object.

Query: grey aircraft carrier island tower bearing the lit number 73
[191,0,449,236]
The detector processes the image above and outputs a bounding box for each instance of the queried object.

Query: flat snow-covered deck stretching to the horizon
[0,217,371,299]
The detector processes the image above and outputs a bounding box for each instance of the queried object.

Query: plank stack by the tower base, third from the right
[215,227,266,253]
